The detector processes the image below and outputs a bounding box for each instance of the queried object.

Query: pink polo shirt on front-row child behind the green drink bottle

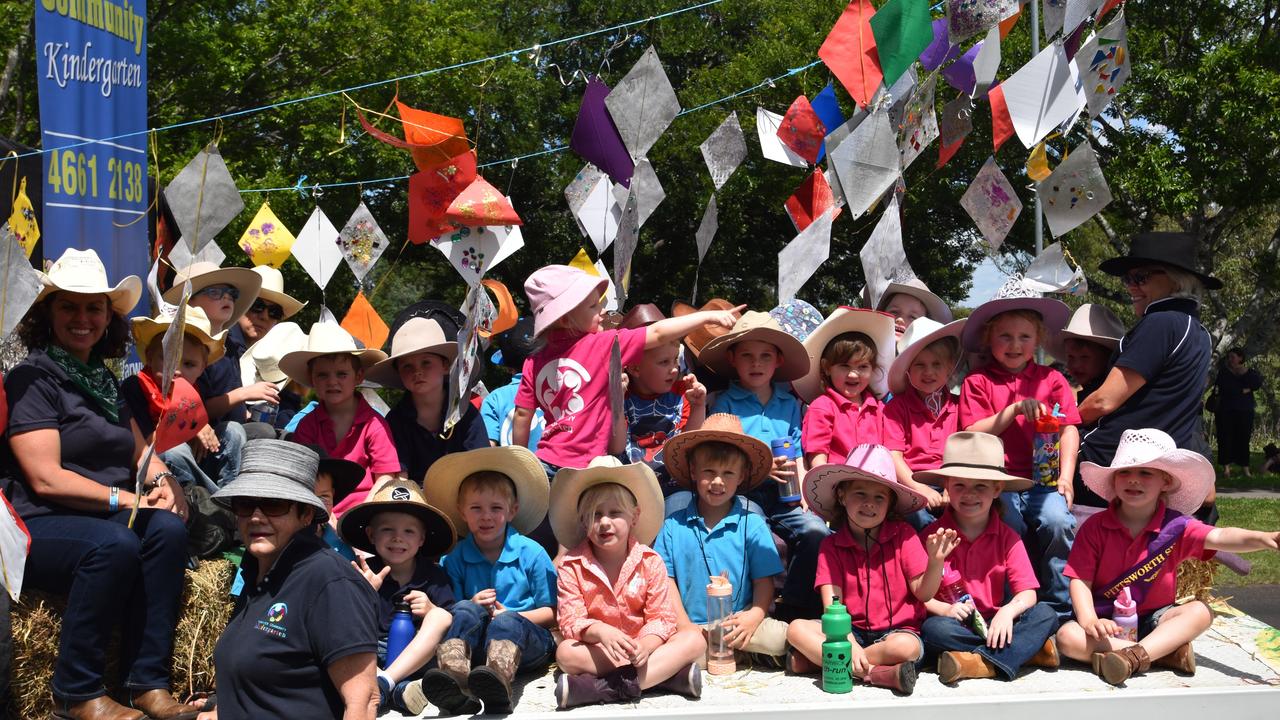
[813,520,929,632]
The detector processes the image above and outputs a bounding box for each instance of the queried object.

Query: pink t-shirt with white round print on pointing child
[516,328,648,468]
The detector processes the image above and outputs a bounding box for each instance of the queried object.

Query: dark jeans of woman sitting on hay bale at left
[26,510,187,702]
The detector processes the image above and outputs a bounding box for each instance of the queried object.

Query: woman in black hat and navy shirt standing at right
[1075,232,1222,519]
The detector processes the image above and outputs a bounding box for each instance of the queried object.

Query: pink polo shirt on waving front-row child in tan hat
[920,507,1039,620]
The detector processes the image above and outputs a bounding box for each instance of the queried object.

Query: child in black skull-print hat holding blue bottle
[340,470,457,715]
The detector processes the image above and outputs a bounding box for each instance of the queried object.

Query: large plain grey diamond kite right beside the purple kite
[604,46,680,160]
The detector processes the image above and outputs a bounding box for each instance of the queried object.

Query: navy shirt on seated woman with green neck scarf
[0,350,134,518]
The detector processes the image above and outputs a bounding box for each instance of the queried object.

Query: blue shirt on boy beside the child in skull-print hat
[440,525,556,612]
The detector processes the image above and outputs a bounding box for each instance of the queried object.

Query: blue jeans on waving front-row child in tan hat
[920,602,1059,680]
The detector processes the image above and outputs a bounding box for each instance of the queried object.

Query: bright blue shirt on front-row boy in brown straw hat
[653,498,782,624]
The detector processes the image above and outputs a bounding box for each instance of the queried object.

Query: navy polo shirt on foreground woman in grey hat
[214,530,378,720]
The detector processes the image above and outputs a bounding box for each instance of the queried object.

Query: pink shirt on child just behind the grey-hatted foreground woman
[292,395,401,516]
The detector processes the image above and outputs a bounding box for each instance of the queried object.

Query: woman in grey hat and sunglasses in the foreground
[200,439,378,720]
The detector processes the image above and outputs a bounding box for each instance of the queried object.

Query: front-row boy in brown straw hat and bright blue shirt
[653,414,788,657]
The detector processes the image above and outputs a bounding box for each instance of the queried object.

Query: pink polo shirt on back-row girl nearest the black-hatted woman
[960,361,1080,478]
